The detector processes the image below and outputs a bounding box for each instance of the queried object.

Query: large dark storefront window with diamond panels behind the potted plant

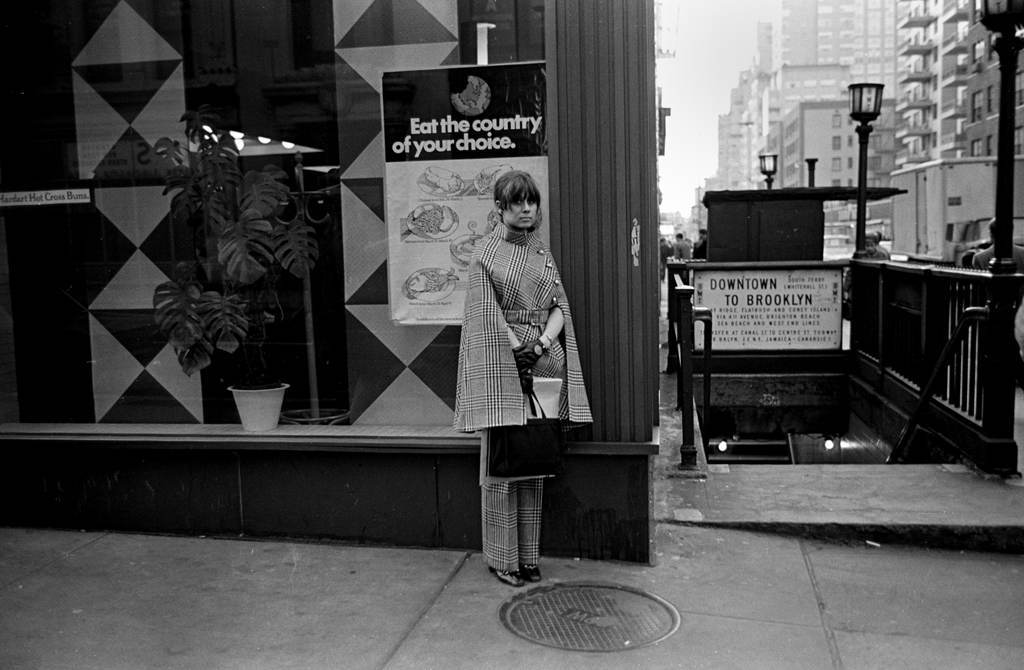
[0,0,544,425]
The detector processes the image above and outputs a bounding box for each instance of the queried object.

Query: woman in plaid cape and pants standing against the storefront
[454,170,592,586]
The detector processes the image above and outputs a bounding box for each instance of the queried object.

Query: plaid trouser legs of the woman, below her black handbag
[480,477,544,571]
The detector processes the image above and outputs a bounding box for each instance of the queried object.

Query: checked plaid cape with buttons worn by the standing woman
[453,226,593,432]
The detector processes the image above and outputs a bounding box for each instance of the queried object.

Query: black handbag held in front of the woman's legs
[487,392,565,477]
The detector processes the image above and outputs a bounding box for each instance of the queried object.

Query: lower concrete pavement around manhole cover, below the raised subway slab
[0,525,1024,670]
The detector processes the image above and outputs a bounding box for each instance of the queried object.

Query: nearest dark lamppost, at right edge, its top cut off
[981,0,1024,275]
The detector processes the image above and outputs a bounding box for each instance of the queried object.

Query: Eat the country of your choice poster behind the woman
[381,62,548,325]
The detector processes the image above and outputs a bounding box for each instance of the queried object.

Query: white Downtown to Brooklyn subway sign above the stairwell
[692,267,843,351]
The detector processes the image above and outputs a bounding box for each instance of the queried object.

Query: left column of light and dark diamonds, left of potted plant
[72,0,193,422]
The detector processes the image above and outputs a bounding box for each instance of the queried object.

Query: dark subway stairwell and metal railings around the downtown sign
[666,261,1024,475]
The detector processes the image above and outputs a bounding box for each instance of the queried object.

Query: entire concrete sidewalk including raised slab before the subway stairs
[0,290,1024,670]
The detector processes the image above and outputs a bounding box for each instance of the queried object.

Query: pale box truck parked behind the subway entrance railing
[892,156,1024,263]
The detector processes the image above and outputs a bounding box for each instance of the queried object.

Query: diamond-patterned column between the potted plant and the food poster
[335,0,459,425]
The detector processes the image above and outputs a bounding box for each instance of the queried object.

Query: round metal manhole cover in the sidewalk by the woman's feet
[499,582,679,652]
